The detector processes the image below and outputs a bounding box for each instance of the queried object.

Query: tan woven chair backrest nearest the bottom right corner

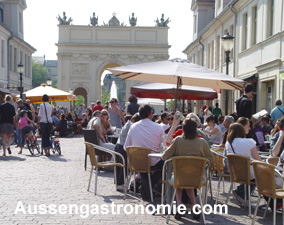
[252,161,276,199]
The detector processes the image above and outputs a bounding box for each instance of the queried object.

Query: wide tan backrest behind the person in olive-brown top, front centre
[172,156,208,189]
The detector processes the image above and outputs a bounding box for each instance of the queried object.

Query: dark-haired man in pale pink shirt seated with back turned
[124,105,164,200]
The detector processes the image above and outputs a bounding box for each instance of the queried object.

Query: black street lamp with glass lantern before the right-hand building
[222,33,234,115]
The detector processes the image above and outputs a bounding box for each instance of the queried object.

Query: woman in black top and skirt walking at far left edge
[0,95,16,156]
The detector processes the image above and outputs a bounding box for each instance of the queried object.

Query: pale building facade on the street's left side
[0,0,36,102]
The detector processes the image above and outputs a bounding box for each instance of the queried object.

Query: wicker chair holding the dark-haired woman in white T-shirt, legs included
[226,154,255,216]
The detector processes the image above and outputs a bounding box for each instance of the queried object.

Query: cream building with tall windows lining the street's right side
[183,0,284,113]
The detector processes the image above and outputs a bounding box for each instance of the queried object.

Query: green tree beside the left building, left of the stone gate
[32,61,49,87]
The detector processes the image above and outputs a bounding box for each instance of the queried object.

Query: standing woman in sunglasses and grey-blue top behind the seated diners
[108,98,125,128]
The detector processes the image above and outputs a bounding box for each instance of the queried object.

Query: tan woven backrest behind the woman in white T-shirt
[227,154,250,184]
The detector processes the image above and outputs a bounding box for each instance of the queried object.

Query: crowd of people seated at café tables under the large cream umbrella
[84,90,284,219]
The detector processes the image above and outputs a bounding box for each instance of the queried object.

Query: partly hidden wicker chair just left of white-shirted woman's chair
[211,151,230,204]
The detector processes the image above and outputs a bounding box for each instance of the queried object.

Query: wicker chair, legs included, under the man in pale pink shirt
[126,146,158,202]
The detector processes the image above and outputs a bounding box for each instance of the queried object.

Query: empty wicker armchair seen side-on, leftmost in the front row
[85,142,127,199]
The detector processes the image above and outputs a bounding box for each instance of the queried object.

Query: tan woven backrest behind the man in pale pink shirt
[126,146,152,173]
